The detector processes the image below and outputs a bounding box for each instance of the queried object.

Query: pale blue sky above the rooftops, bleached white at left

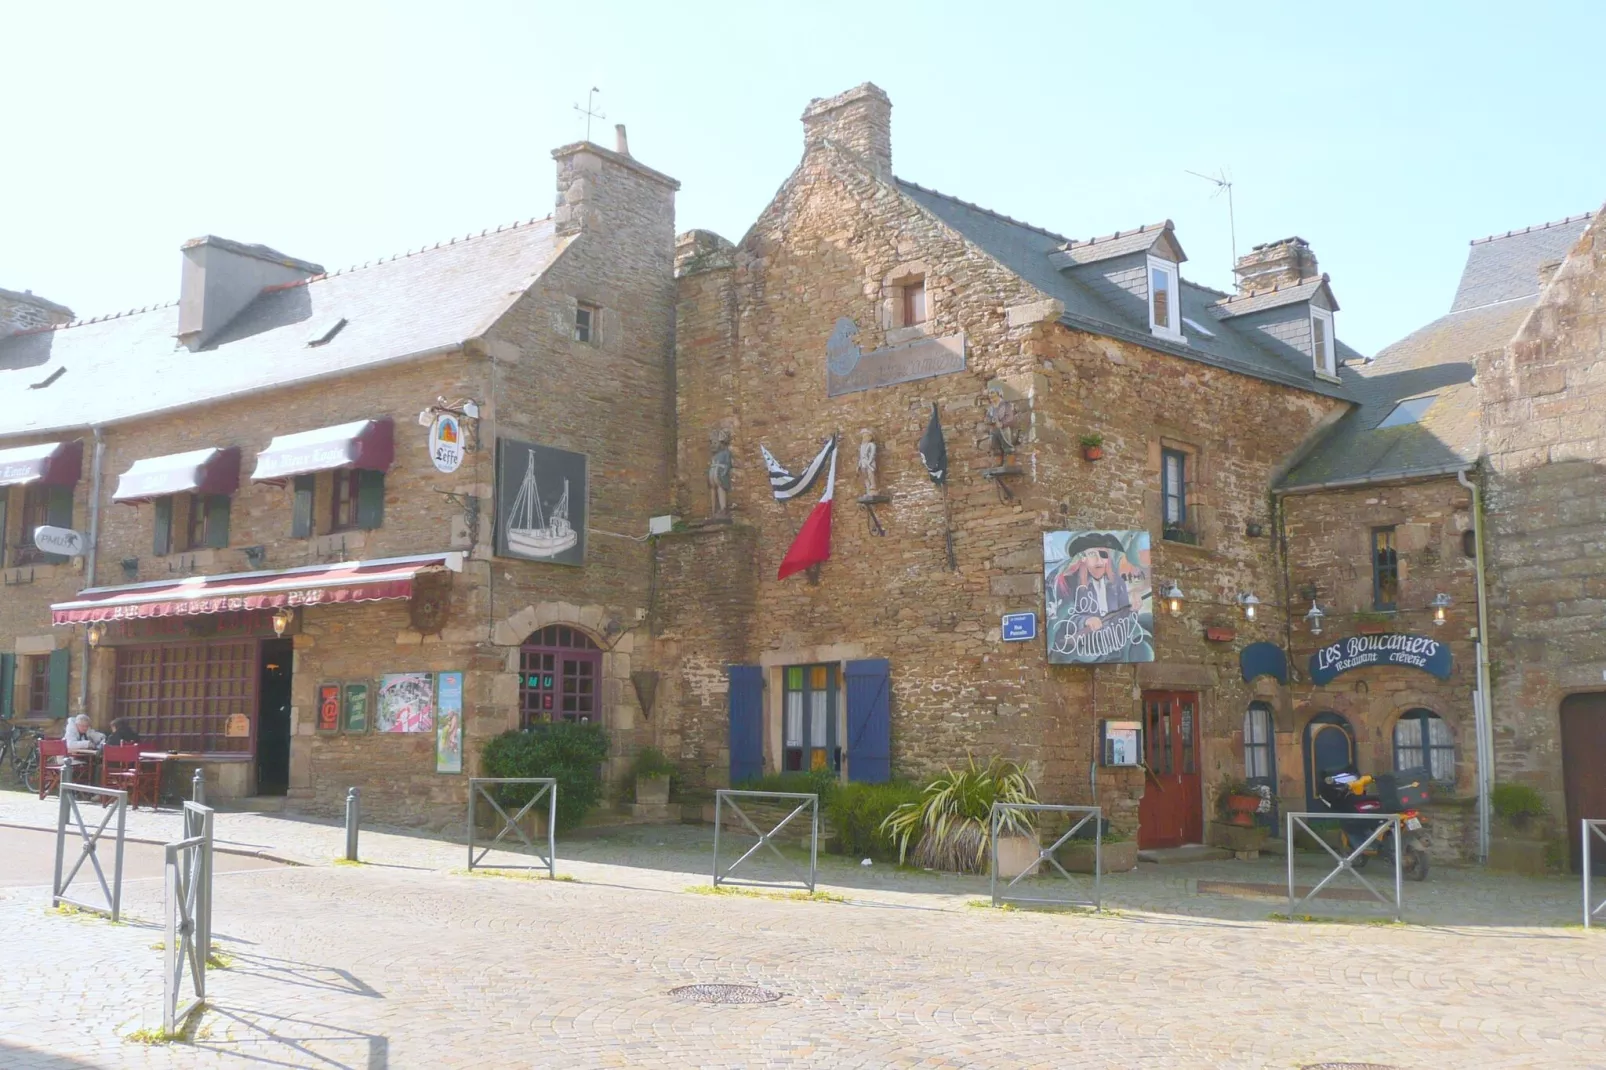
[0,0,1606,352]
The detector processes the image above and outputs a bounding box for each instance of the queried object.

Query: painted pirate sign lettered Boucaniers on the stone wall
[1042,532,1155,665]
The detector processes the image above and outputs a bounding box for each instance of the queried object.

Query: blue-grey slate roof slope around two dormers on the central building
[898,178,1360,400]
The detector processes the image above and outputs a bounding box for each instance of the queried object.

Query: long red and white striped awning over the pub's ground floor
[50,553,463,625]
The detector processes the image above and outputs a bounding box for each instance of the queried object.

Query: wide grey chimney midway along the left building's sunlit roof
[178,235,323,350]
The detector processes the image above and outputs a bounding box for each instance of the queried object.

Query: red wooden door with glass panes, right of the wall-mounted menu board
[1137,691,1205,847]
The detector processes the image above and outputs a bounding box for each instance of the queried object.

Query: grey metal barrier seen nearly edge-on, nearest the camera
[162,802,212,1035]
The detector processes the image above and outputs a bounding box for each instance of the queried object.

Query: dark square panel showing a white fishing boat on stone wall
[496,439,588,566]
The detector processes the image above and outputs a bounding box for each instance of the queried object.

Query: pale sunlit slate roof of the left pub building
[0,218,567,437]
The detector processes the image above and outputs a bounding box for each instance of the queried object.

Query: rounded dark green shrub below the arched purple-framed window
[480,721,609,832]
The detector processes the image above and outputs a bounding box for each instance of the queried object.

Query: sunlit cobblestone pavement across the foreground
[0,780,1606,1070]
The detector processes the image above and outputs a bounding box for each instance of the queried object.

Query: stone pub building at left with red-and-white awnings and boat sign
[0,130,678,821]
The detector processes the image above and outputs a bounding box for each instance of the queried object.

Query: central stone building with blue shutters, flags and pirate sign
[655,85,1359,845]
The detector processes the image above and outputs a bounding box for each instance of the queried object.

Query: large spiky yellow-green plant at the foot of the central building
[882,758,1039,879]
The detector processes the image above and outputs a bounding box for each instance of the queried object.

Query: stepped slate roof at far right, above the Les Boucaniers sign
[1282,215,1590,490]
